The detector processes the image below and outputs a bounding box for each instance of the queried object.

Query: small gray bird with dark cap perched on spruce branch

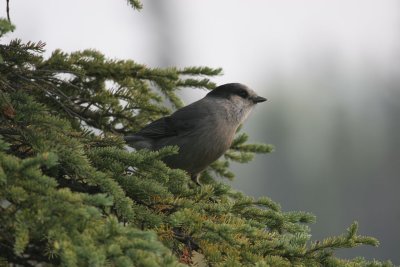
[124,83,267,185]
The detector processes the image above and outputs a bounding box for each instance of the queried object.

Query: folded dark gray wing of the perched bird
[135,101,209,139]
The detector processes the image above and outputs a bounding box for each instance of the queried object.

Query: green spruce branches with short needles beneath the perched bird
[0,4,392,266]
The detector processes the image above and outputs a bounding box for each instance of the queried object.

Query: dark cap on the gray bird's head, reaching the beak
[207,83,267,104]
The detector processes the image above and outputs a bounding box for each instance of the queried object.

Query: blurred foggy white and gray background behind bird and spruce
[1,0,400,264]
